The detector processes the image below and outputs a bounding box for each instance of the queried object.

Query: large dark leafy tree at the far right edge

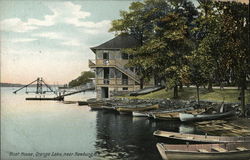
[193,0,250,114]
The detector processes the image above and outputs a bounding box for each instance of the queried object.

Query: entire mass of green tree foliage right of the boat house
[110,0,250,111]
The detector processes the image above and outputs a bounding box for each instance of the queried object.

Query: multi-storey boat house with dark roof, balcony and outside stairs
[89,34,155,99]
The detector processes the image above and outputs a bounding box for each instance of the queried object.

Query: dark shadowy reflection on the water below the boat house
[95,111,202,160]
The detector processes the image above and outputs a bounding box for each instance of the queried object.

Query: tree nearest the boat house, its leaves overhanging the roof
[110,0,172,88]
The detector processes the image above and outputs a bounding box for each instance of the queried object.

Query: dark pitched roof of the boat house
[90,34,140,52]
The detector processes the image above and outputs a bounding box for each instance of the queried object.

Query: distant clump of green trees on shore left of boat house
[69,71,95,87]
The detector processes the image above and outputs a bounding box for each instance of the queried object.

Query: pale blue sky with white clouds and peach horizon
[0,0,133,84]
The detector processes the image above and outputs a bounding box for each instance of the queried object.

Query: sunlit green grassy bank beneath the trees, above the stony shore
[120,88,250,103]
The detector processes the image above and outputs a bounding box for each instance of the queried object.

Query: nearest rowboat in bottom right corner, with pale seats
[156,143,250,160]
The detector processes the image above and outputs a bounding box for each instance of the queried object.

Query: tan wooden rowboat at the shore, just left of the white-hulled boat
[151,109,205,121]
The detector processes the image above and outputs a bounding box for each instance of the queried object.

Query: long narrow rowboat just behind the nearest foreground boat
[153,130,250,143]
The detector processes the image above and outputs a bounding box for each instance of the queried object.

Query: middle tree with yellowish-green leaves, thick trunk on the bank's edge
[147,0,197,98]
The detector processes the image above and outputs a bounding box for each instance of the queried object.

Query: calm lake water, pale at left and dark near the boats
[1,87,197,160]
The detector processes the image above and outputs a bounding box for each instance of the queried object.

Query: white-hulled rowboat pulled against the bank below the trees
[179,111,235,122]
